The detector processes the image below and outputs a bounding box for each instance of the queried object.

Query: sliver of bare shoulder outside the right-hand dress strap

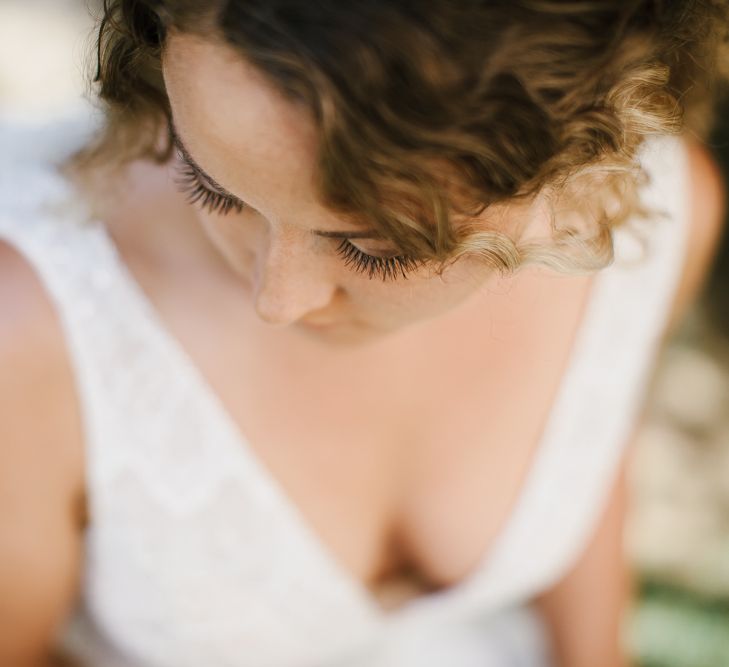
[669,138,726,330]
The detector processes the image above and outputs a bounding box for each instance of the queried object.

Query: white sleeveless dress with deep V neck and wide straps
[0,115,688,667]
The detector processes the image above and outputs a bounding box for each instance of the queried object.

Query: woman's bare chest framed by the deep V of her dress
[156,270,588,606]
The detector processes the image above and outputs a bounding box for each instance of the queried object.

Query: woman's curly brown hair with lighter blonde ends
[73,0,729,272]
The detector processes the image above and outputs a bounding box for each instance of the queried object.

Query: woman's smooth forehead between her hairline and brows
[162,32,317,214]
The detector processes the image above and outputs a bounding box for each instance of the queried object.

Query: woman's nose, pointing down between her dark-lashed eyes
[253,231,337,326]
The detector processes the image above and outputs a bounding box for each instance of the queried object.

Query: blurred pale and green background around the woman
[0,0,729,667]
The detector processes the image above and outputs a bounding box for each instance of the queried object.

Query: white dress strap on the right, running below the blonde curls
[478,137,690,599]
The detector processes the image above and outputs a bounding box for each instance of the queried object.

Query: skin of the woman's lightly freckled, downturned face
[163,33,544,342]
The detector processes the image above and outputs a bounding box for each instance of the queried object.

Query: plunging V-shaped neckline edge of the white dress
[86,210,611,623]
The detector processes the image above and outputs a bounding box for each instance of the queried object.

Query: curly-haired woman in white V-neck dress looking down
[0,0,727,667]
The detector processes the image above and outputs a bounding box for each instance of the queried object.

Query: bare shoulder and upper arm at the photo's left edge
[0,242,84,665]
